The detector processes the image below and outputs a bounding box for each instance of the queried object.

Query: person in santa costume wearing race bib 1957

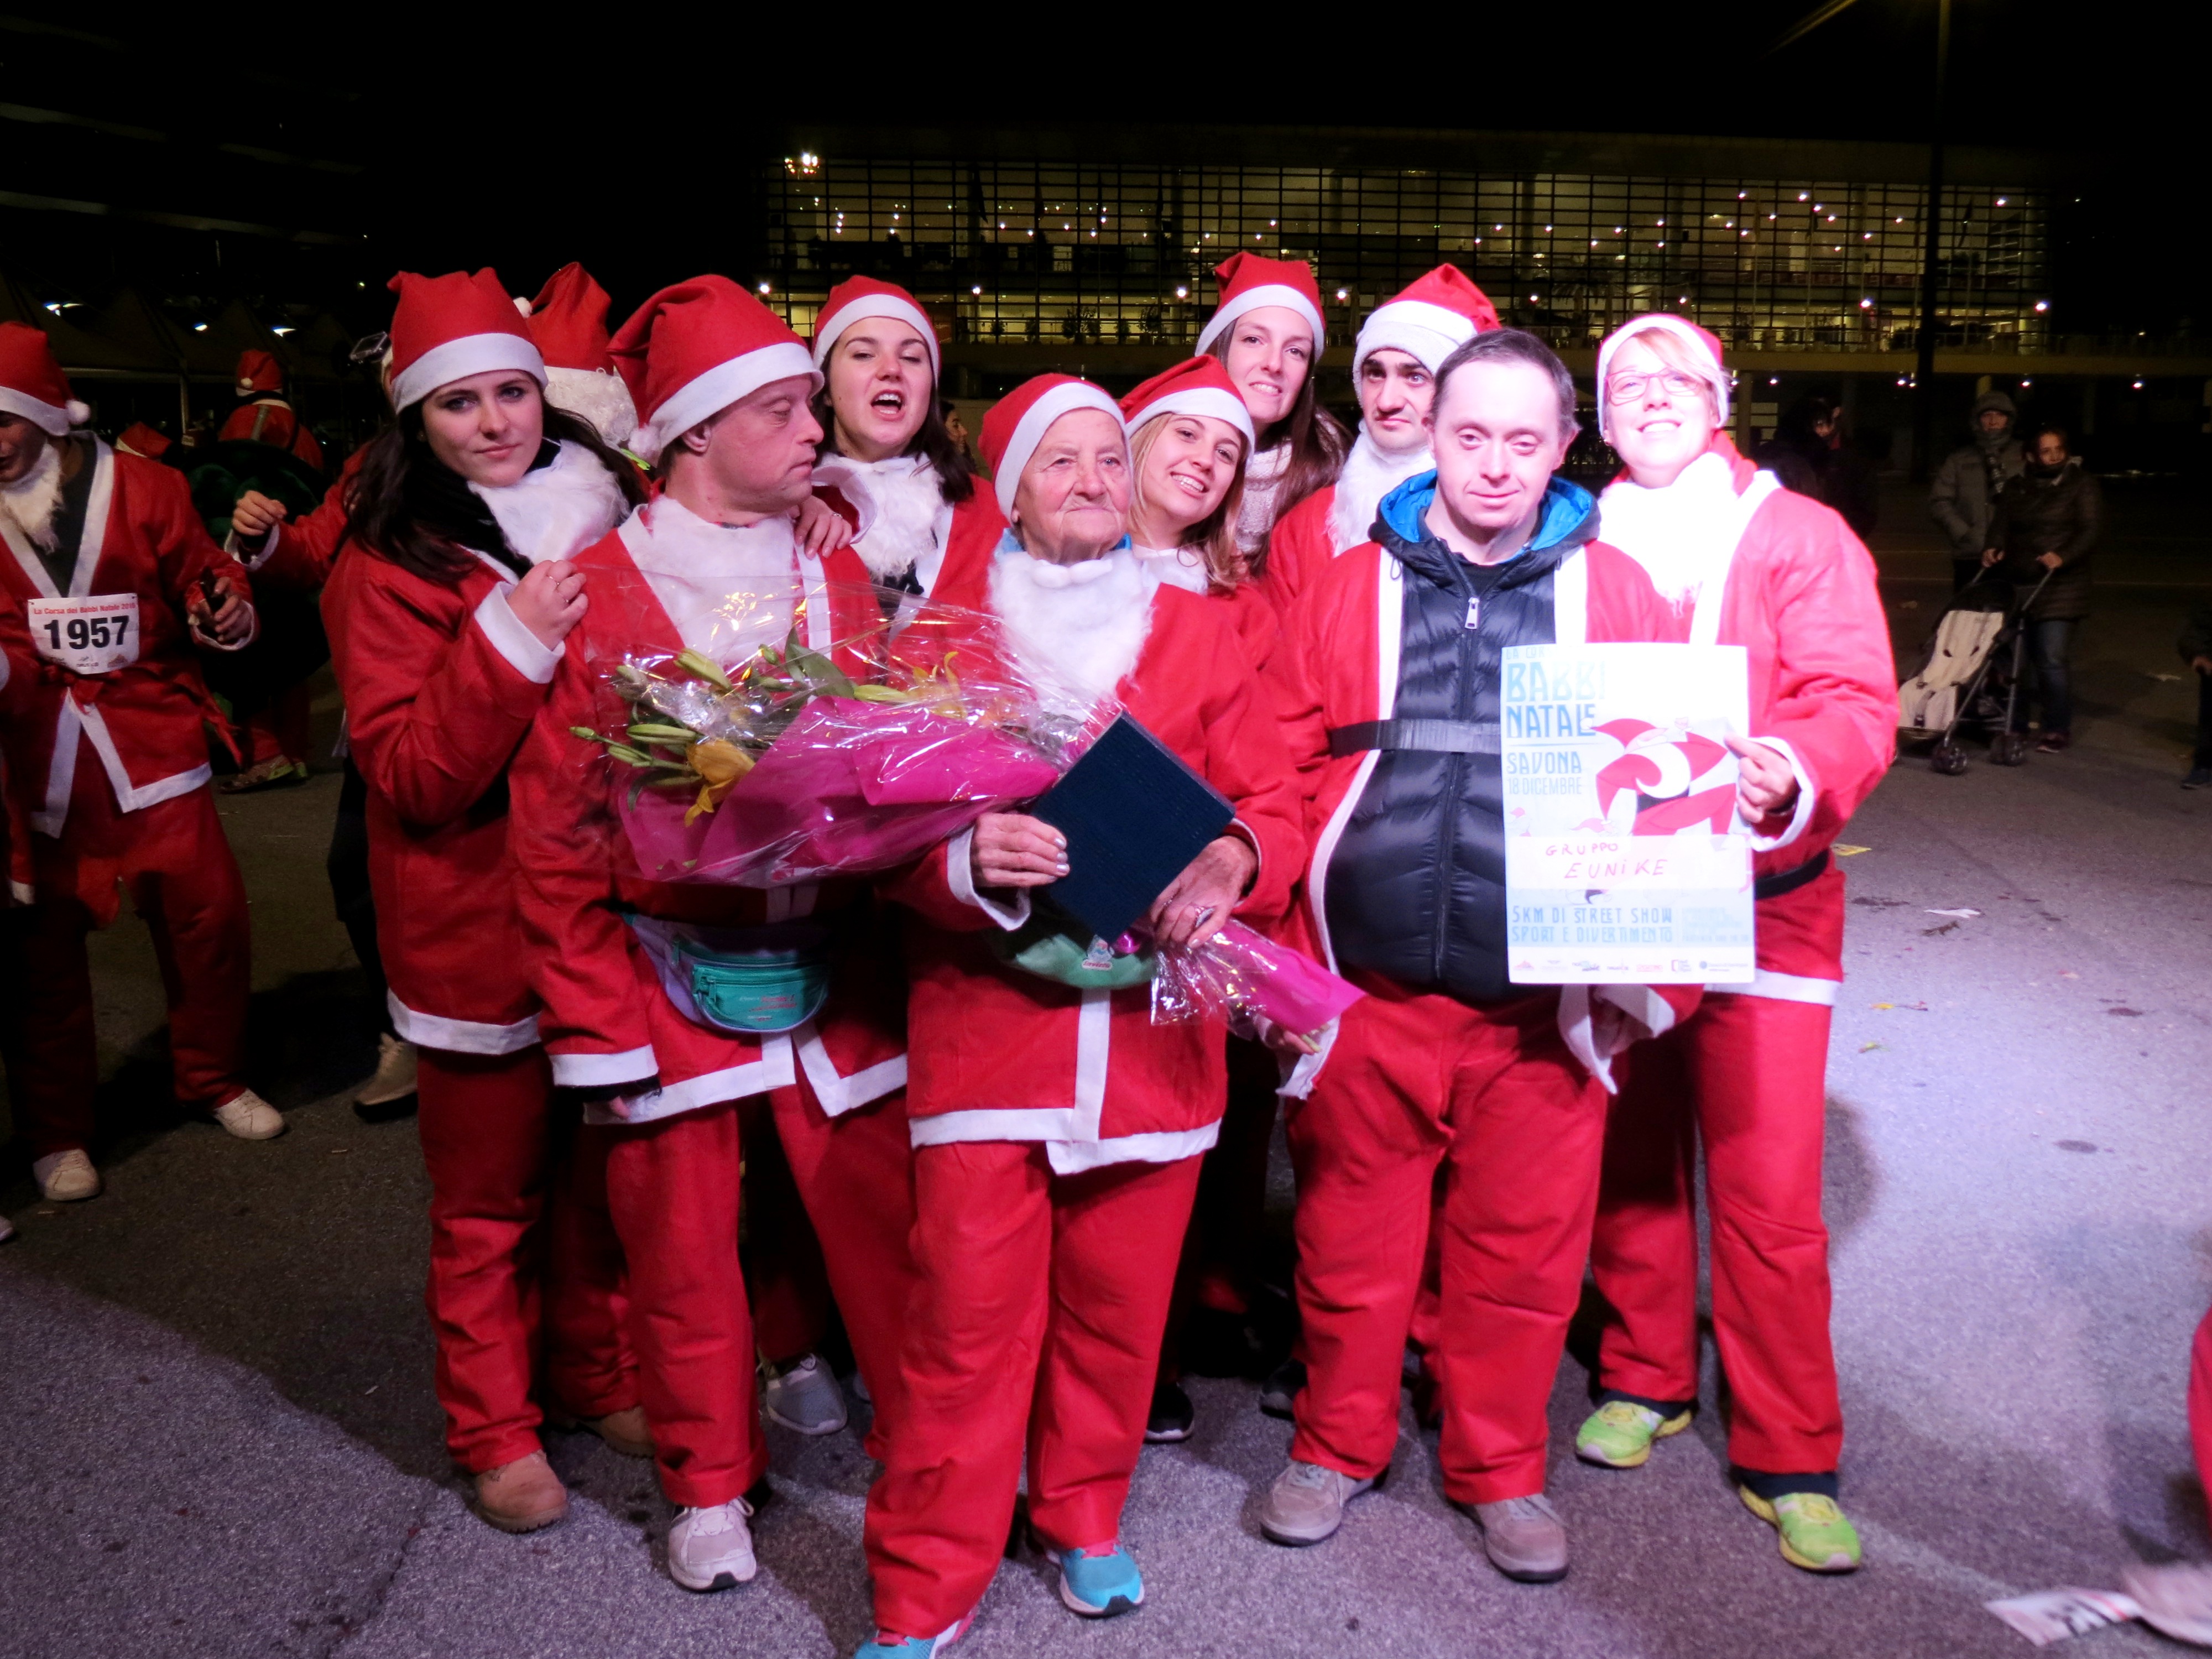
[0,323,271,1199]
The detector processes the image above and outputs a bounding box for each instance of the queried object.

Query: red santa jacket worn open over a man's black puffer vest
[1276,498,1701,1097]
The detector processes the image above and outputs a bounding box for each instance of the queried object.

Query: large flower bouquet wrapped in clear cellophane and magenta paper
[575,577,1115,887]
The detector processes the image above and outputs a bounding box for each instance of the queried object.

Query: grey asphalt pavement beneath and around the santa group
[0,482,2212,1659]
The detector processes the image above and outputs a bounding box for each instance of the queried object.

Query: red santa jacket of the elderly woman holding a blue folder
[887,546,1303,1172]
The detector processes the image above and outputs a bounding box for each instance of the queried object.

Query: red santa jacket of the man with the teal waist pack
[511,495,907,1124]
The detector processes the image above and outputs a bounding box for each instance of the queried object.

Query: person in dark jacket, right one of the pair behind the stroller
[1982,425,2104,754]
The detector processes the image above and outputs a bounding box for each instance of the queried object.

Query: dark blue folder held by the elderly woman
[1029,714,1237,945]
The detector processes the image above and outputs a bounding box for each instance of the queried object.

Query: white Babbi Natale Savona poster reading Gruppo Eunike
[1500,646,1754,984]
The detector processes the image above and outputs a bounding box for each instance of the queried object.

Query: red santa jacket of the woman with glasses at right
[1599,436,1898,1002]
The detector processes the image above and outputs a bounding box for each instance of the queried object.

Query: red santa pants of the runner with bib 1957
[11,765,252,1157]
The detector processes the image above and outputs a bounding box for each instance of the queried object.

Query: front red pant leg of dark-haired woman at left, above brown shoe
[416,1046,553,1473]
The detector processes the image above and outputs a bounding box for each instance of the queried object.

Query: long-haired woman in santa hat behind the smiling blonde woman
[1199,254,1349,575]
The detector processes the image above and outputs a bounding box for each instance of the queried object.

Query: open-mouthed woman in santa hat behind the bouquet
[814,276,1004,593]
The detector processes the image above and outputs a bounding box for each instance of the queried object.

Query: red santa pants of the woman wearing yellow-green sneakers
[1590,995,1843,1475]
